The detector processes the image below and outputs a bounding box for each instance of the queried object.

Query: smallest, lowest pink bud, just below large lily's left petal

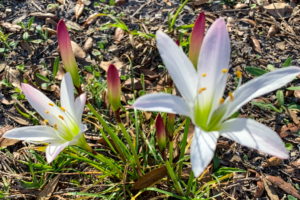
[155,114,167,151]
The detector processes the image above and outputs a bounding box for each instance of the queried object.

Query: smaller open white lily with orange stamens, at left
[3,73,91,163]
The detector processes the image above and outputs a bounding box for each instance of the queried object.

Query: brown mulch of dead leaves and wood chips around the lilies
[0,0,300,199]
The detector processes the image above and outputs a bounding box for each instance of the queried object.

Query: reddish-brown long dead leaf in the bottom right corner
[266,175,300,199]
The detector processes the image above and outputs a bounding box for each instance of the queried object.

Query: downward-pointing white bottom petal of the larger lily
[191,127,219,177]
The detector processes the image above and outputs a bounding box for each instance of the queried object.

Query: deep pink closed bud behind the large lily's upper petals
[189,12,205,68]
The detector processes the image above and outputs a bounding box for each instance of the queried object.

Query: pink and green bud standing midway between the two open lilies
[107,64,121,111]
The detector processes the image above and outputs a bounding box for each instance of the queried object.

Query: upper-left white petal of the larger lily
[156,31,198,101]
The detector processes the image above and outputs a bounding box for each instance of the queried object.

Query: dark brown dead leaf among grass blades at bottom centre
[132,166,168,190]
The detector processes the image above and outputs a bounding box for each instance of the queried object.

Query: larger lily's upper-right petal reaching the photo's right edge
[224,67,300,118]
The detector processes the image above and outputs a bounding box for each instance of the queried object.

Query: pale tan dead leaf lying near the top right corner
[264,2,293,18]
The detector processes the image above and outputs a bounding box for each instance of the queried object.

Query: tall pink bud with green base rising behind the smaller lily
[57,20,80,87]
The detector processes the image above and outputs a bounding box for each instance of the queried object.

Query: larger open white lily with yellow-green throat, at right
[133,18,300,177]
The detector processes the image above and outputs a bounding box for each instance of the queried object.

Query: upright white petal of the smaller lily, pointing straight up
[60,72,77,116]
